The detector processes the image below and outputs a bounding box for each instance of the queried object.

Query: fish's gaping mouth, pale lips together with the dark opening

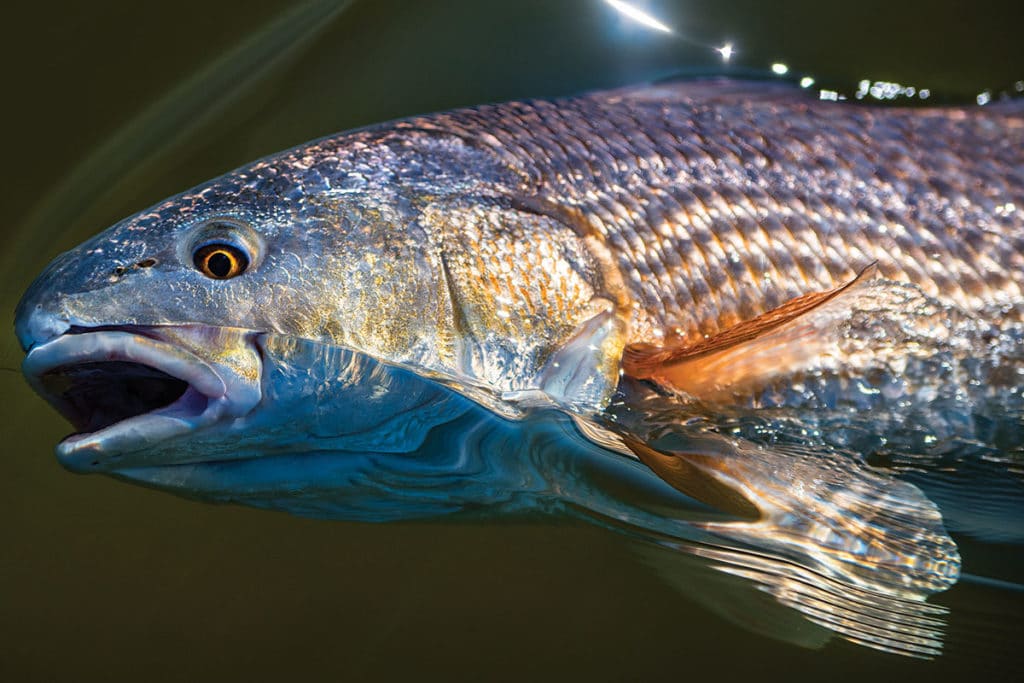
[22,328,261,471]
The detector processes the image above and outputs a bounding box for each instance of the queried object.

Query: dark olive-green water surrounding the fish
[0,0,1024,681]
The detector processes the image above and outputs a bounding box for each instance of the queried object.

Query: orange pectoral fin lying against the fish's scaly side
[623,263,877,400]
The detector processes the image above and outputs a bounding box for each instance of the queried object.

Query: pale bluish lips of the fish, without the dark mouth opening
[22,327,261,471]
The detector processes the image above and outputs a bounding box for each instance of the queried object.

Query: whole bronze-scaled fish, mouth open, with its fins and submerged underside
[16,82,1024,656]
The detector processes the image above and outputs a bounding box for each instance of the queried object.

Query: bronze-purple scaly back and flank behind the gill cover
[411,83,1024,342]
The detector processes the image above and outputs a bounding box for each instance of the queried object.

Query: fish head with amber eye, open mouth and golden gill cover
[15,132,620,471]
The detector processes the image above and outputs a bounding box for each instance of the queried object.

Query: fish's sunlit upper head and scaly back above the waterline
[18,82,1024,421]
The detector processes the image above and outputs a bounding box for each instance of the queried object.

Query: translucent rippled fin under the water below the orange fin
[602,419,959,657]
